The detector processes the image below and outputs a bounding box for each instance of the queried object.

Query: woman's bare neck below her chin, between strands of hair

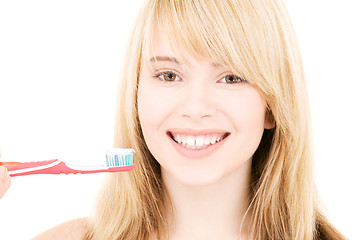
[162,160,251,240]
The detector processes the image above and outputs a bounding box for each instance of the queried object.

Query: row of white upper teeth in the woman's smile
[172,134,223,149]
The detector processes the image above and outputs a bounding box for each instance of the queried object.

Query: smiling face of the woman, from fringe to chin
[138,31,272,185]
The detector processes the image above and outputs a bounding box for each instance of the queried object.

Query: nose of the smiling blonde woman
[179,82,216,120]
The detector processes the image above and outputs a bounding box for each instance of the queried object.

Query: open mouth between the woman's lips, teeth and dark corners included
[167,131,230,149]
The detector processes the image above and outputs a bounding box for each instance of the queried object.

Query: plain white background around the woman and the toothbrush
[0,0,362,240]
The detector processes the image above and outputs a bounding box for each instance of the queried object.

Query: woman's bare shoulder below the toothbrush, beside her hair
[32,218,89,240]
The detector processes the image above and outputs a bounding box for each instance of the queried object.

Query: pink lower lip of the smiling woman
[169,136,229,158]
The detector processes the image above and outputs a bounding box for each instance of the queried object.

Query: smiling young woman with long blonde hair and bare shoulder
[3,0,345,240]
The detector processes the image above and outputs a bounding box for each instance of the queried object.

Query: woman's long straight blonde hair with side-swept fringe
[89,0,345,240]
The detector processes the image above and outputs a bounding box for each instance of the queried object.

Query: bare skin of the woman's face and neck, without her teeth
[138,27,273,240]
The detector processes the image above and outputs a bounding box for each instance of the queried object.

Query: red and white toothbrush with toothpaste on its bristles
[0,148,134,177]
